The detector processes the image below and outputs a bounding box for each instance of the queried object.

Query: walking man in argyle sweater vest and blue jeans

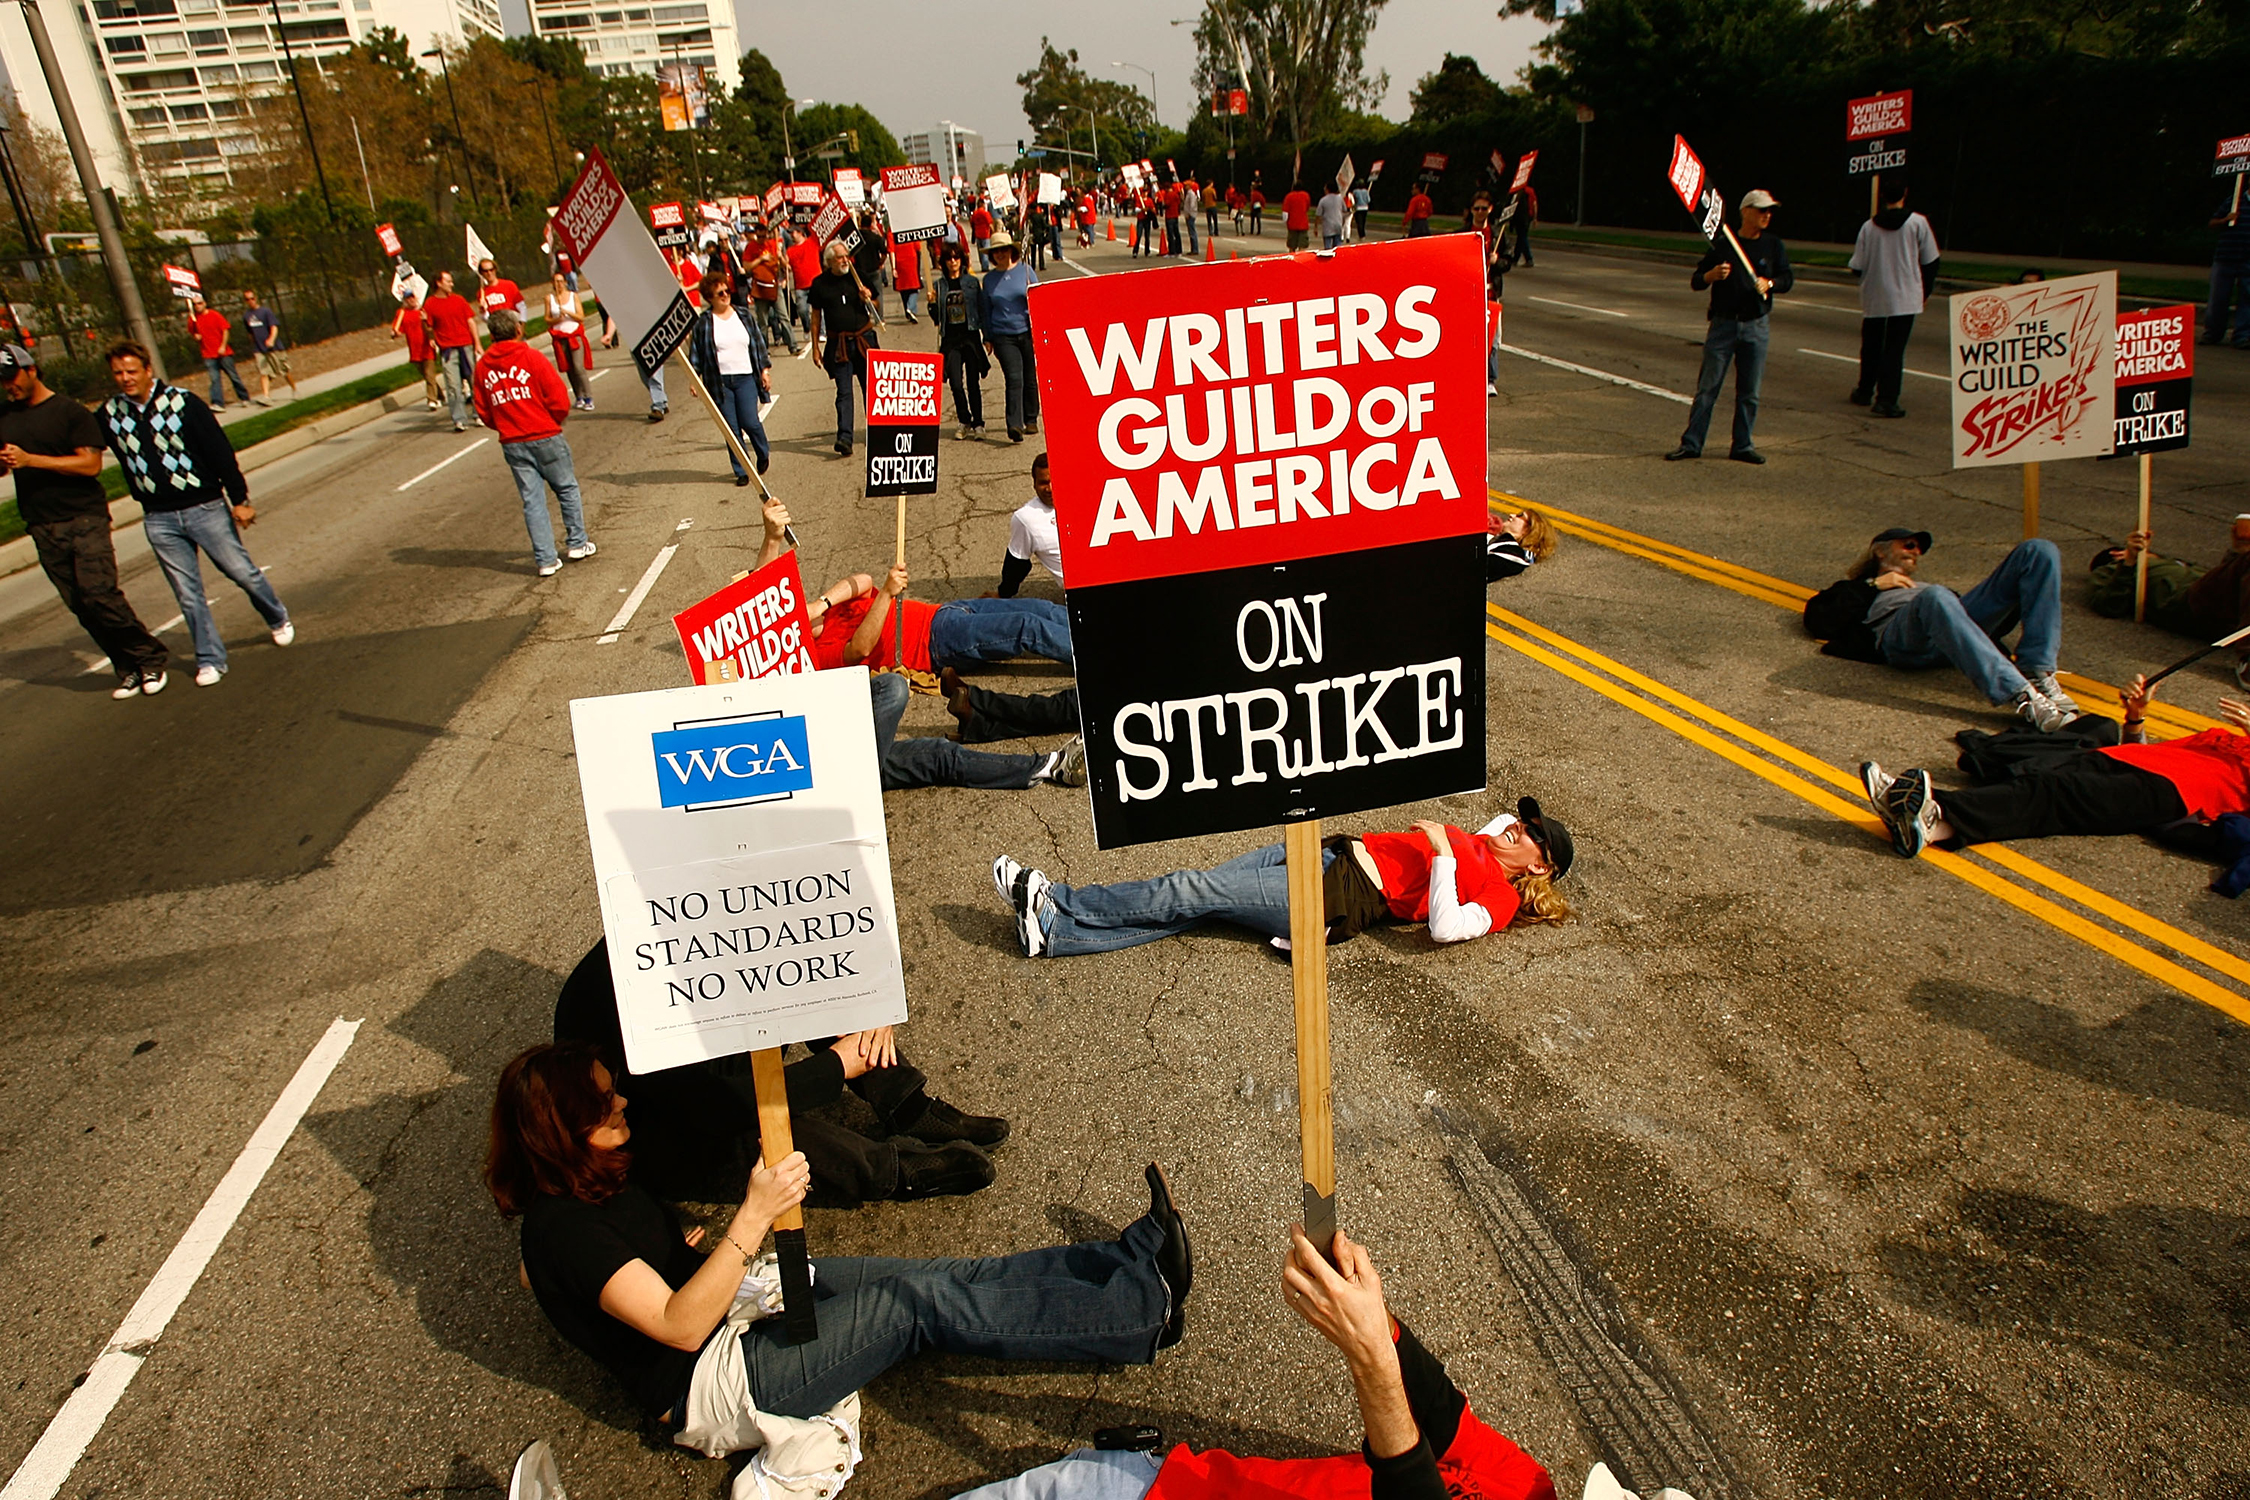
[97,340,297,688]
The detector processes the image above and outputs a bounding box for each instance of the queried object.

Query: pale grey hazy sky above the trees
[502,0,1546,151]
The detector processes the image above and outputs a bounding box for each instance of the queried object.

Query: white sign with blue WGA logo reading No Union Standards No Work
[569,670,907,1073]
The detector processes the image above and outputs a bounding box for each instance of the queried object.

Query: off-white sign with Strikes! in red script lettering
[1946,270,2117,468]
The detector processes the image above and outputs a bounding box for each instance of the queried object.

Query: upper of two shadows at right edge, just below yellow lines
[1906,981,2250,1120]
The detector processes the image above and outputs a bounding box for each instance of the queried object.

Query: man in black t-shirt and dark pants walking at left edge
[0,344,167,699]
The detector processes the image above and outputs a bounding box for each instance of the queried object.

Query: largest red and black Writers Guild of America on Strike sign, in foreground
[1031,234,1485,848]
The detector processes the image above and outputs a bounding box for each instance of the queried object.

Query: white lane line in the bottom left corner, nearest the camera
[0,1016,360,1500]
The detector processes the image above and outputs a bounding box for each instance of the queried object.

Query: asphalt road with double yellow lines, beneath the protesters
[0,226,2250,1500]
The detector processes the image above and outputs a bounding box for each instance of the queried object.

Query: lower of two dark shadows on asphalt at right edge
[1879,1187,2250,1406]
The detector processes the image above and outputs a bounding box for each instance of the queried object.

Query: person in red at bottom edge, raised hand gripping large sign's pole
[954,1226,1555,1500]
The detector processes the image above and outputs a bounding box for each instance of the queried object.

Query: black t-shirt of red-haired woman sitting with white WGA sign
[522,1187,706,1417]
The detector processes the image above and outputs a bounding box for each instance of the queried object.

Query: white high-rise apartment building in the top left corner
[0,0,504,196]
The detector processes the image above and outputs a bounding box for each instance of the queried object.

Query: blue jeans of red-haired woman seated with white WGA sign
[743,1217,1170,1417]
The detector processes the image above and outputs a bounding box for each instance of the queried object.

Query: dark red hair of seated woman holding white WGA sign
[484,1041,632,1219]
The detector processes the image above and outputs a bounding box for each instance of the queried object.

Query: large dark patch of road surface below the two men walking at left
[0,614,533,915]
